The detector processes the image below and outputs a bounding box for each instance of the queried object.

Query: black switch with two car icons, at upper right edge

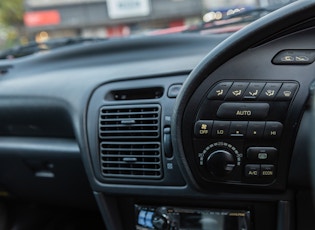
[272,50,315,65]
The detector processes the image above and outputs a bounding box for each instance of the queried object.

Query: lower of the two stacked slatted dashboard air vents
[101,142,162,179]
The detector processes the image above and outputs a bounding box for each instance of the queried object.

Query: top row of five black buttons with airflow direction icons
[208,81,298,101]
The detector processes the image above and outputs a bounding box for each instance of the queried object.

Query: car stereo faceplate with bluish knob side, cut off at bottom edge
[135,205,251,230]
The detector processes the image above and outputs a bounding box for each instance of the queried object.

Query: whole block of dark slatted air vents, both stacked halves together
[99,105,162,179]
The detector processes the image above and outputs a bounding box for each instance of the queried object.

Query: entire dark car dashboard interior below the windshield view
[0,0,315,230]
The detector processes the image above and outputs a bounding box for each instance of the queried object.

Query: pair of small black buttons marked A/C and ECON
[245,164,275,178]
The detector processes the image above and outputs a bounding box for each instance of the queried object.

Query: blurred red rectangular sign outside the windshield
[24,10,61,27]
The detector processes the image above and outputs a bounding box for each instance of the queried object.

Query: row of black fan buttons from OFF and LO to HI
[194,120,283,138]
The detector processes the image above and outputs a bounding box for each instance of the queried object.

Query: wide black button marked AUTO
[217,102,270,120]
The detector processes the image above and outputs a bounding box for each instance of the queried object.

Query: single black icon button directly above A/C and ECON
[247,147,277,162]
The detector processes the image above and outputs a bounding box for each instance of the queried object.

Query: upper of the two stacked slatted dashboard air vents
[99,105,160,140]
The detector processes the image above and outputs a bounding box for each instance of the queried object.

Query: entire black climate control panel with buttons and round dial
[189,81,299,184]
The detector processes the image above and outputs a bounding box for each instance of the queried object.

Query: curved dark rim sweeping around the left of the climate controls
[172,1,315,188]
